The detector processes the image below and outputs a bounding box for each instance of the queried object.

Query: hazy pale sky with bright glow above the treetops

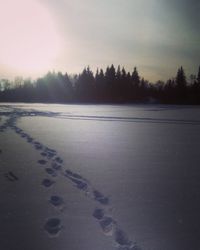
[0,0,200,81]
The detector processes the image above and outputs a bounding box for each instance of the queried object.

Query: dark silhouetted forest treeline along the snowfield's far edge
[0,65,200,104]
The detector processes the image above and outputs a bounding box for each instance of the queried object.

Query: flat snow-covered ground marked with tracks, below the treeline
[0,104,200,250]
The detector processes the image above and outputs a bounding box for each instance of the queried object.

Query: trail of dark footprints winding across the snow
[0,109,141,250]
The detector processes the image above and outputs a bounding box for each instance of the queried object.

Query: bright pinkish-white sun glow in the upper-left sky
[0,0,61,76]
